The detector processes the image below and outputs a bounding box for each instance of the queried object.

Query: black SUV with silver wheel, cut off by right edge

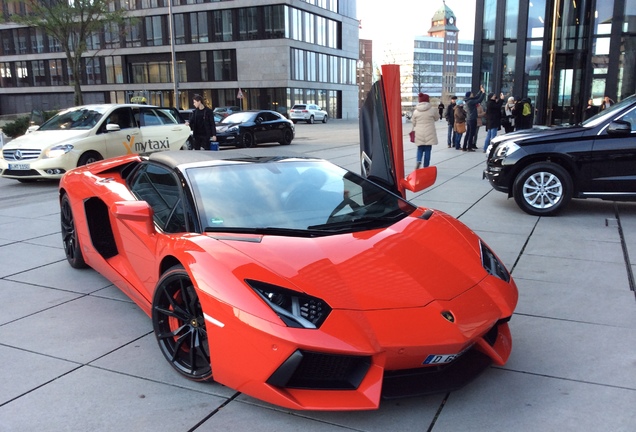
[483,95,636,216]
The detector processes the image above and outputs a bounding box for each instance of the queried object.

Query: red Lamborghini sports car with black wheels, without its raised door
[59,66,517,410]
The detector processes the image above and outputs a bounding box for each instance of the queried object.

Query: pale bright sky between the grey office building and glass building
[357,0,475,63]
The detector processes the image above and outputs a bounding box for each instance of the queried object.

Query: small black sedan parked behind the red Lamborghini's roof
[216,110,295,147]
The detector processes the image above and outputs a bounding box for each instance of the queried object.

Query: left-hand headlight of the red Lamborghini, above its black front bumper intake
[245,280,331,329]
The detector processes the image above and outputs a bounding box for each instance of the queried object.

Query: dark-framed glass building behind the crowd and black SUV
[472,0,636,125]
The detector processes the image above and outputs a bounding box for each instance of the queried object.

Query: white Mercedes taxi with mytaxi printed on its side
[0,104,190,182]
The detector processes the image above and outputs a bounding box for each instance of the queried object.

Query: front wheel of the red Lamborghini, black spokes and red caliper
[152,265,212,381]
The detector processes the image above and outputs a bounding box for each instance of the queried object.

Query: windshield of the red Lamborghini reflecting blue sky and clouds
[186,159,415,235]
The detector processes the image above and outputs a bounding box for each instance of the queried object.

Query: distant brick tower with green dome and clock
[428,1,459,104]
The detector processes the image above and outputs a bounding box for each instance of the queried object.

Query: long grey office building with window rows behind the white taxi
[0,0,358,118]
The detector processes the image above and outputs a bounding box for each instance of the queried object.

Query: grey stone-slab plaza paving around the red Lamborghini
[0,120,636,432]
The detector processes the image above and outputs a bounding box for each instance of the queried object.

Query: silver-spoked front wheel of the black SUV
[513,162,573,216]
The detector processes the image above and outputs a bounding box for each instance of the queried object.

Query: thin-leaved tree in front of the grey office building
[8,0,128,105]
